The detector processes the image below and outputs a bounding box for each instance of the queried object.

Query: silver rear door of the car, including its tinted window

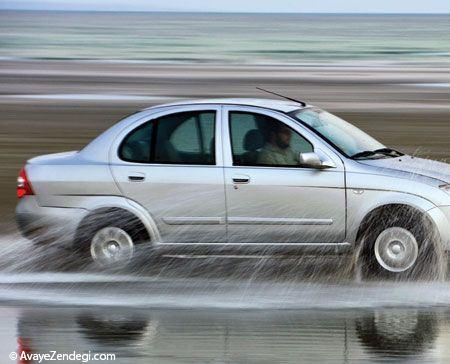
[111,106,226,244]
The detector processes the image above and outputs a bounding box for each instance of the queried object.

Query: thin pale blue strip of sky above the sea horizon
[0,0,450,13]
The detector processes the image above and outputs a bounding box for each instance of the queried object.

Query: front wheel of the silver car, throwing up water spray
[357,208,447,280]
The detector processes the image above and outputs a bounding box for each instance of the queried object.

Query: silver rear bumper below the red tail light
[16,196,87,243]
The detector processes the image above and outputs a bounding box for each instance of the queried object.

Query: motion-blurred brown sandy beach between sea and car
[0,60,450,220]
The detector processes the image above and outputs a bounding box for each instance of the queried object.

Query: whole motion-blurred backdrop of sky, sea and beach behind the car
[0,0,450,222]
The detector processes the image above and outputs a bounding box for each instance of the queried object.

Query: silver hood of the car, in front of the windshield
[358,155,450,183]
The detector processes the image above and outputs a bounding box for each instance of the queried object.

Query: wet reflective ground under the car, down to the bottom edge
[0,237,450,364]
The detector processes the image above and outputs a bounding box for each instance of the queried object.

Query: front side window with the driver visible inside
[229,112,313,167]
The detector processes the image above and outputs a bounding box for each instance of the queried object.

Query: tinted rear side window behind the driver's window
[119,111,216,165]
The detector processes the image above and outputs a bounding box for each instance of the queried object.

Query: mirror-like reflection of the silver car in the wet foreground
[13,309,450,363]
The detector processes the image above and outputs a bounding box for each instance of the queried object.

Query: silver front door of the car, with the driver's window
[223,106,346,244]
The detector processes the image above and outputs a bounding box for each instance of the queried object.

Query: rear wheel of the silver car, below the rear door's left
[74,211,150,269]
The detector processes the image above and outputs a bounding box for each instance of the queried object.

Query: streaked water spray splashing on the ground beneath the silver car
[0,219,450,309]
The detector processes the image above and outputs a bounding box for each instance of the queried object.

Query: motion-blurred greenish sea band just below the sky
[0,10,450,67]
